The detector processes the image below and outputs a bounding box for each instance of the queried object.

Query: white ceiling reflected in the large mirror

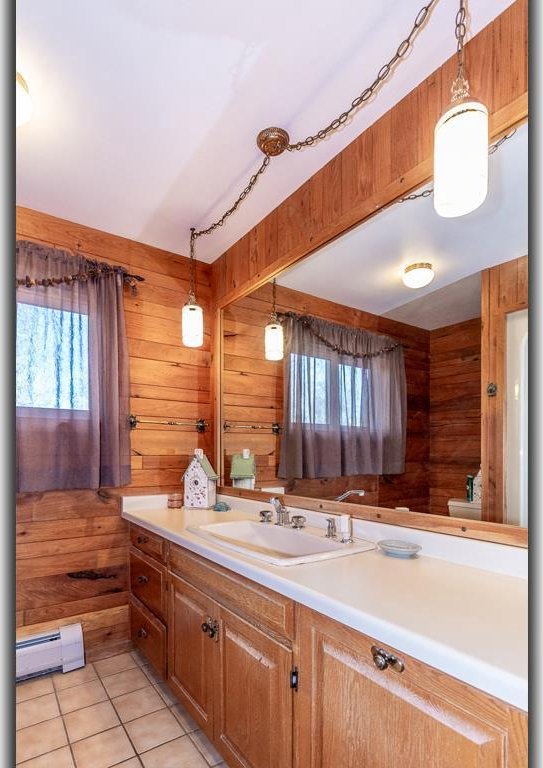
[277,124,528,329]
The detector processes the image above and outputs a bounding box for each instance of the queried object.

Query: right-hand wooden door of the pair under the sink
[215,608,294,768]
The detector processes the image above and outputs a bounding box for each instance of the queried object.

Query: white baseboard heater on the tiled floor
[15,624,85,682]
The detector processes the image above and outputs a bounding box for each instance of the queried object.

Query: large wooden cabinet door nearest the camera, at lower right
[294,609,528,768]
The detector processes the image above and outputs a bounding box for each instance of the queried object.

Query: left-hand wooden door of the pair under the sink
[168,575,217,738]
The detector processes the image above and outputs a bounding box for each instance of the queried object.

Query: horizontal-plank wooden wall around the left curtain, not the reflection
[16,208,213,656]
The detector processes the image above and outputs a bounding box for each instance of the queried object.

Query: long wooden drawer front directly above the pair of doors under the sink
[169,544,294,640]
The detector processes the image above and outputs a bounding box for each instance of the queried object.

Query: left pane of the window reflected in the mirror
[290,353,330,424]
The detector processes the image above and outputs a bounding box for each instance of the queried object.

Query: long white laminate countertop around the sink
[122,496,528,710]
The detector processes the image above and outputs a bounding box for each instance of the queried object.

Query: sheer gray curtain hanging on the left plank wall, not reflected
[16,241,130,491]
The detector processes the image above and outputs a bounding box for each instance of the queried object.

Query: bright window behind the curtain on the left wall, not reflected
[16,302,89,411]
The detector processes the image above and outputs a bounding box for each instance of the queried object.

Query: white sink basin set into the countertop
[188,520,375,565]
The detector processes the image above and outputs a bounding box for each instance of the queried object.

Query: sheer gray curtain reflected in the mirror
[278,313,406,479]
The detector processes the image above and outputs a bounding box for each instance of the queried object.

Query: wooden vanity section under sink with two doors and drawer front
[168,545,294,768]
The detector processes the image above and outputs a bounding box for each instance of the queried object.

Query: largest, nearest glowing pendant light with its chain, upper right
[434,0,488,218]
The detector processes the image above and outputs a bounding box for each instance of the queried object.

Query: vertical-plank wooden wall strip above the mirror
[213,0,528,306]
